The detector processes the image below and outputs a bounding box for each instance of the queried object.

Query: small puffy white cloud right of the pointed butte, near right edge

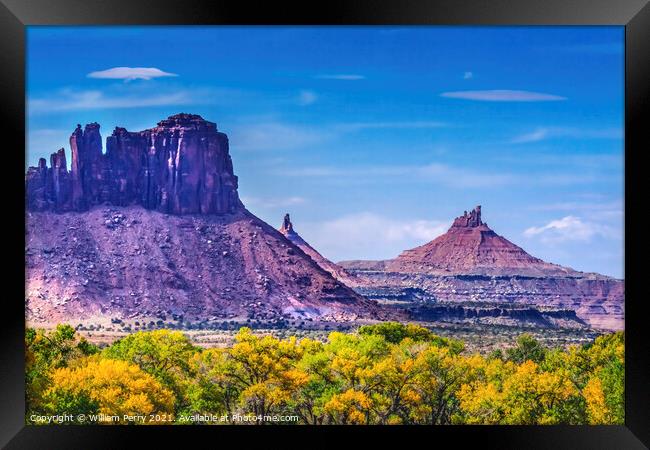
[524,216,619,243]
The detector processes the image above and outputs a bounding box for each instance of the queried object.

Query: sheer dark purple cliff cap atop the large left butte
[25,113,244,214]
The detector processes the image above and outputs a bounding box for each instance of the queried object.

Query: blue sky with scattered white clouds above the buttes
[27,27,624,277]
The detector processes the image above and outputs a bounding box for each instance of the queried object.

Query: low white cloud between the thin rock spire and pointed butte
[300,212,449,261]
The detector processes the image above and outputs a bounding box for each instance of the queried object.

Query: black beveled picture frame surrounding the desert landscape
[0,0,650,449]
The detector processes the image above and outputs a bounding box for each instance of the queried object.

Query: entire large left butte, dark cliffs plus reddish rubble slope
[26,114,385,323]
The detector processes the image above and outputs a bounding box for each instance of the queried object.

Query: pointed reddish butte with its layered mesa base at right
[338,207,625,330]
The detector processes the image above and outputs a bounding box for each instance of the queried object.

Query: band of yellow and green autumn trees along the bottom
[26,323,625,425]
